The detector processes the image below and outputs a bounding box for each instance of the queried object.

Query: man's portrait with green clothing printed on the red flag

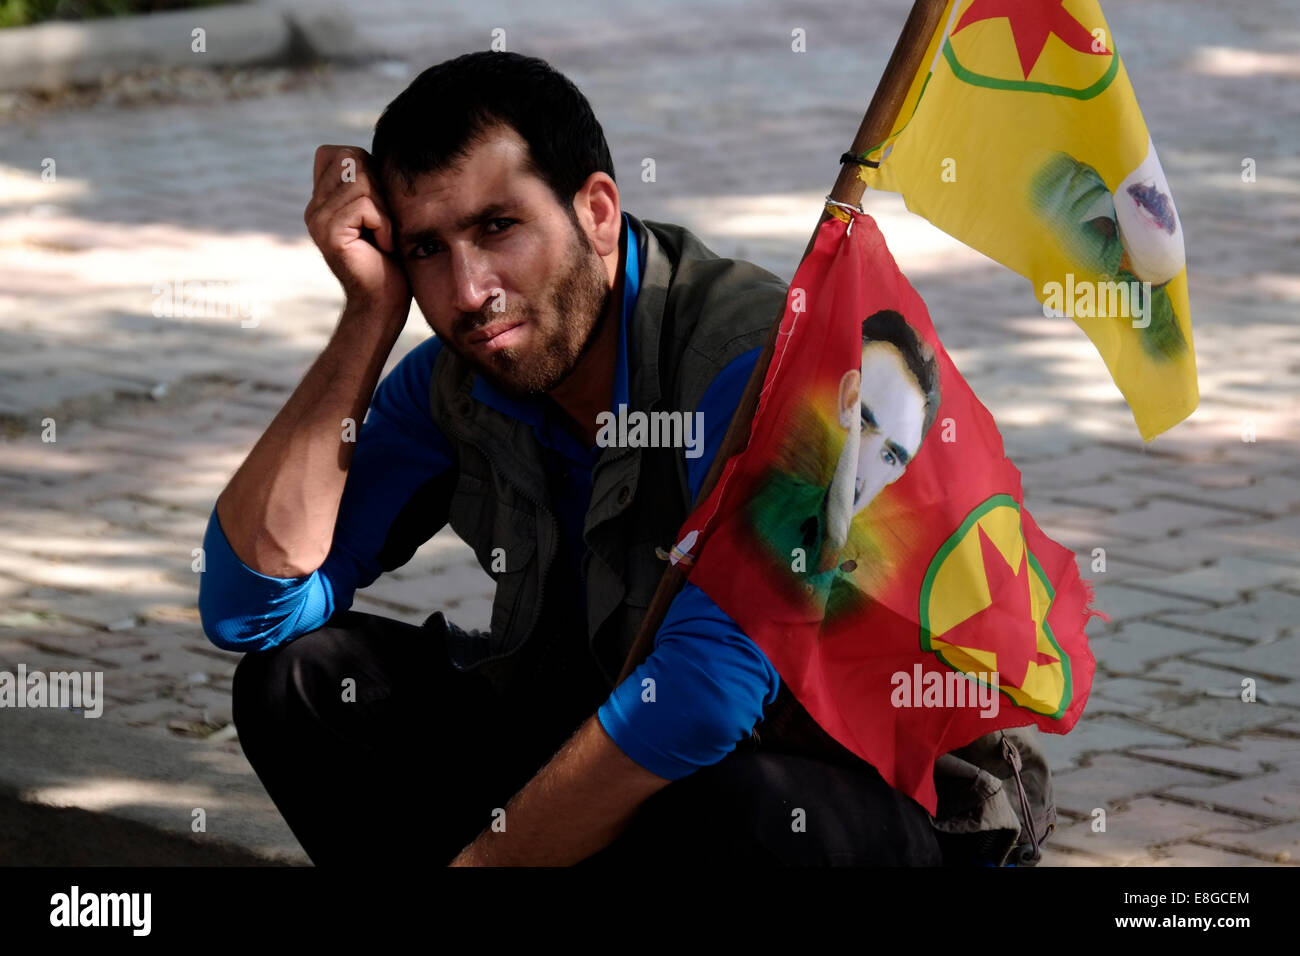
[750,310,940,619]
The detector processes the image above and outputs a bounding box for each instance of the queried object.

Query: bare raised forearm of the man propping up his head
[217,307,406,578]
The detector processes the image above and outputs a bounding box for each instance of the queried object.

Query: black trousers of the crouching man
[234,611,941,866]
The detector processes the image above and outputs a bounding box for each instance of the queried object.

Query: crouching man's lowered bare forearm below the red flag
[451,717,671,866]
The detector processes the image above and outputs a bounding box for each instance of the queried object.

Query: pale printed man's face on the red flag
[853,342,926,514]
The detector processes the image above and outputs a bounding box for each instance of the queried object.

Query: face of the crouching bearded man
[389,126,610,397]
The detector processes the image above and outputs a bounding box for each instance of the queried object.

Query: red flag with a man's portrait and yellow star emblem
[675,213,1095,814]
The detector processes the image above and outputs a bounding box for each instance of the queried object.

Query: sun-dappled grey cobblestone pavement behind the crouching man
[0,0,1300,865]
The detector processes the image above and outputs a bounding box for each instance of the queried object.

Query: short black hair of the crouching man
[371,51,614,220]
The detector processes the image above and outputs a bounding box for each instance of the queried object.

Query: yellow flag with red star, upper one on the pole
[861,0,1199,441]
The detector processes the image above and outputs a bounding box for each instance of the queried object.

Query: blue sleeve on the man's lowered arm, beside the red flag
[597,349,781,780]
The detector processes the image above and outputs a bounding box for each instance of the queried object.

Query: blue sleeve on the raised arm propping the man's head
[199,338,455,652]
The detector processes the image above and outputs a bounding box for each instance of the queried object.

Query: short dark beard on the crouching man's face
[446,222,611,398]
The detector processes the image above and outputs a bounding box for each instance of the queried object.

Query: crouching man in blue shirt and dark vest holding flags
[199,53,940,865]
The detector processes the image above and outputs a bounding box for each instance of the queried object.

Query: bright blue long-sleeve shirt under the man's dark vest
[199,216,780,780]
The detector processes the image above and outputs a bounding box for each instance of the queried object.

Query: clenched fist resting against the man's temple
[303,146,411,319]
